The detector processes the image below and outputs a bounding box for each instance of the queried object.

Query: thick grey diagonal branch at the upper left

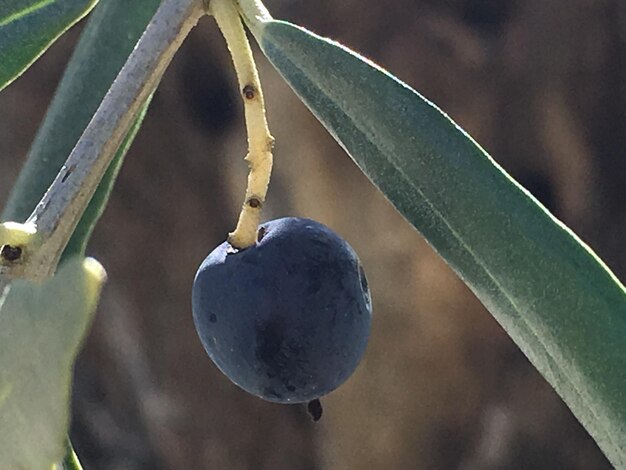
[0,0,206,284]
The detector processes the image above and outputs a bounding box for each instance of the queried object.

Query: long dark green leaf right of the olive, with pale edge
[253,21,626,468]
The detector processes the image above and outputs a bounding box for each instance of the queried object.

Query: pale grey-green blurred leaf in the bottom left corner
[0,257,106,470]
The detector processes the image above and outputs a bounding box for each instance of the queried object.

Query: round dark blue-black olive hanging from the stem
[192,217,372,403]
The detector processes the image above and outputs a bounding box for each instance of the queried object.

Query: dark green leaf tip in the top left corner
[0,0,98,90]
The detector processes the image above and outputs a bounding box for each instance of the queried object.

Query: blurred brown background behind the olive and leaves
[0,0,626,470]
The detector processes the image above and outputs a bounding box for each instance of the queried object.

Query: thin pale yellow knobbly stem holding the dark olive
[209,0,274,249]
